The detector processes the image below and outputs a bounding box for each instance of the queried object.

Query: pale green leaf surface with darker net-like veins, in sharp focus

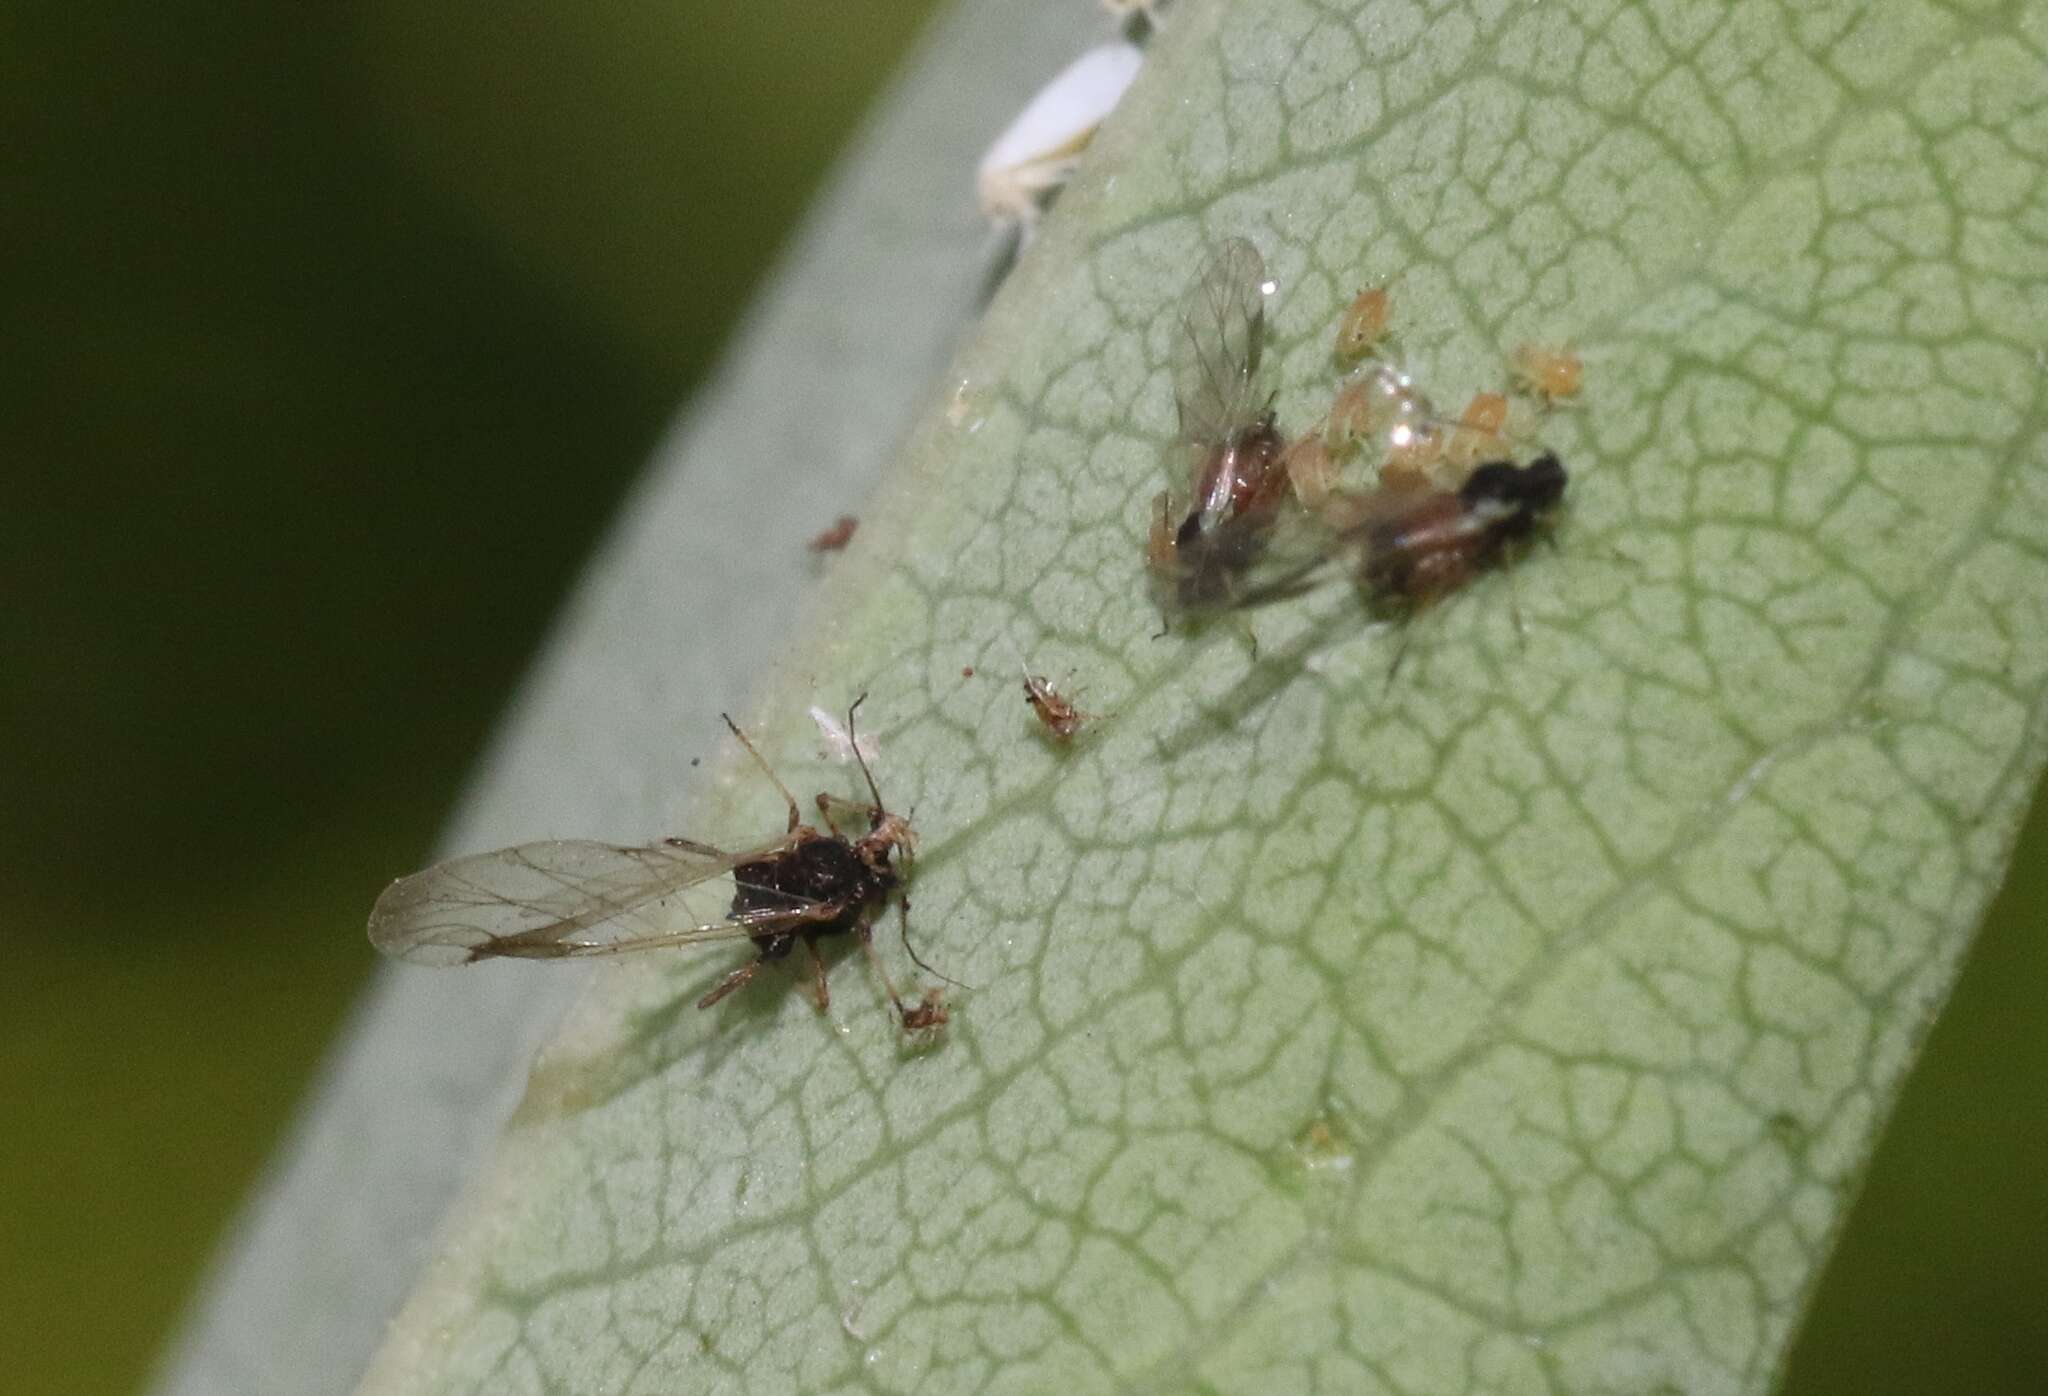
[365,0,2048,1394]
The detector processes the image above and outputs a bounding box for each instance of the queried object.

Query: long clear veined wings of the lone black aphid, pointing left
[369,835,836,964]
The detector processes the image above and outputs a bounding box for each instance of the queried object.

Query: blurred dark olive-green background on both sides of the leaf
[0,0,2048,1396]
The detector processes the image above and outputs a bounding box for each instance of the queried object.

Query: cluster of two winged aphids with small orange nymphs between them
[1145,237,1579,620]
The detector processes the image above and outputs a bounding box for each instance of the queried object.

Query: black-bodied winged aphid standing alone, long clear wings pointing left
[369,696,946,1032]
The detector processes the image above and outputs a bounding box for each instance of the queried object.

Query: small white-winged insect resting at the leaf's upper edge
[975,43,1145,246]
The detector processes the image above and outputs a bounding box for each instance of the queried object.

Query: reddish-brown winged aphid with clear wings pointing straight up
[1145,237,1318,614]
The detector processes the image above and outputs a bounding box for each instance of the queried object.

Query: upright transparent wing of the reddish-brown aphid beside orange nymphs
[1174,237,1266,446]
